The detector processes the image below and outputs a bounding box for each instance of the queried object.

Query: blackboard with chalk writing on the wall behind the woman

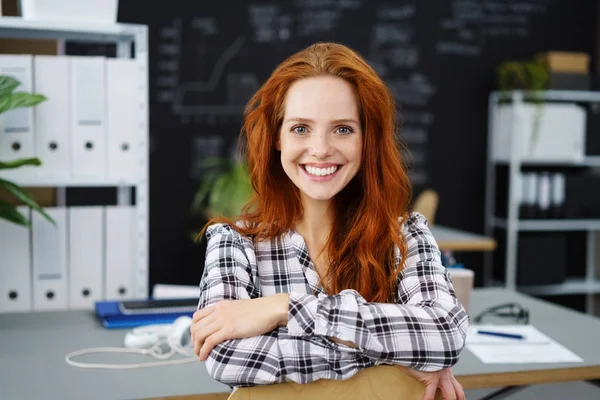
[111,0,596,285]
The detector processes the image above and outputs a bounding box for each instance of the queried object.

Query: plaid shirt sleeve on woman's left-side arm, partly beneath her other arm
[198,224,375,386]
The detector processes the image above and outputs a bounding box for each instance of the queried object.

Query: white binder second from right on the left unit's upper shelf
[70,56,107,178]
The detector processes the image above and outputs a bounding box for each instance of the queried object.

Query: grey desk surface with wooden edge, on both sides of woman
[0,289,600,400]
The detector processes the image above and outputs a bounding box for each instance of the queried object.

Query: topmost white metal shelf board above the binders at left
[0,17,141,42]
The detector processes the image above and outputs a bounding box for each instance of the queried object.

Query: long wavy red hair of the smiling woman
[200,43,412,302]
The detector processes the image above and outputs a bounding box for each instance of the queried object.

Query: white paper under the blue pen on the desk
[466,325,583,364]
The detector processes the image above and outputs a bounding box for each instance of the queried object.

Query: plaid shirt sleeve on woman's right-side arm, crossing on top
[288,213,469,371]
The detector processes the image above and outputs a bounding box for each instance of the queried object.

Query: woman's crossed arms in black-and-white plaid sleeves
[196,218,468,386]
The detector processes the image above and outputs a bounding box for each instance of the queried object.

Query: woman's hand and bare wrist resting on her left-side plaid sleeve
[190,293,289,361]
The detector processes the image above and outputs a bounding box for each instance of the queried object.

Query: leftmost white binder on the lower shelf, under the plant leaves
[0,206,31,313]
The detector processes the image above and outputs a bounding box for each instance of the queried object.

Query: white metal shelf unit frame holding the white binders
[0,17,149,298]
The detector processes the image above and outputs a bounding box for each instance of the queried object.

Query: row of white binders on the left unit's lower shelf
[0,206,136,313]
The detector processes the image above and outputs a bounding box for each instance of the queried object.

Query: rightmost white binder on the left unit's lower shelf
[104,206,135,300]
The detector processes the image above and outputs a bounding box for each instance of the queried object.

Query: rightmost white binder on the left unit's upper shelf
[106,58,141,181]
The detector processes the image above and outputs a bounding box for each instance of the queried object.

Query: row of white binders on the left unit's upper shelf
[0,54,142,180]
